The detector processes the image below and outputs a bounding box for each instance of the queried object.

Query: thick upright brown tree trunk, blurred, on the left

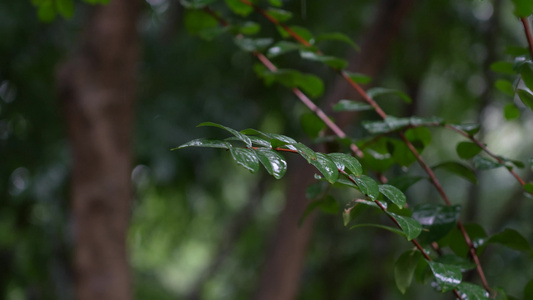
[57,0,140,300]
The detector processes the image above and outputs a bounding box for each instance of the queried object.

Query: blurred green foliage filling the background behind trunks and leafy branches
[0,0,533,300]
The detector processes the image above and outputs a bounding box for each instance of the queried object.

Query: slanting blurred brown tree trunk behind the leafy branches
[255,0,412,300]
